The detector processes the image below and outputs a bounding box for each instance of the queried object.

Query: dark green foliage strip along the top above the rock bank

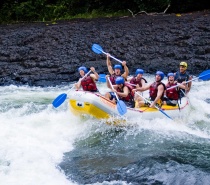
[0,0,210,23]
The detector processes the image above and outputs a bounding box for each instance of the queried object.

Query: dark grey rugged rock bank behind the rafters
[0,11,210,86]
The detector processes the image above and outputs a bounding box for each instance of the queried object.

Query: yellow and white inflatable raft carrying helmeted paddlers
[68,91,189,119]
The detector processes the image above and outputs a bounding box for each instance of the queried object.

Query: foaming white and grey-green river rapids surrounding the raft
[0,76,210,185]
